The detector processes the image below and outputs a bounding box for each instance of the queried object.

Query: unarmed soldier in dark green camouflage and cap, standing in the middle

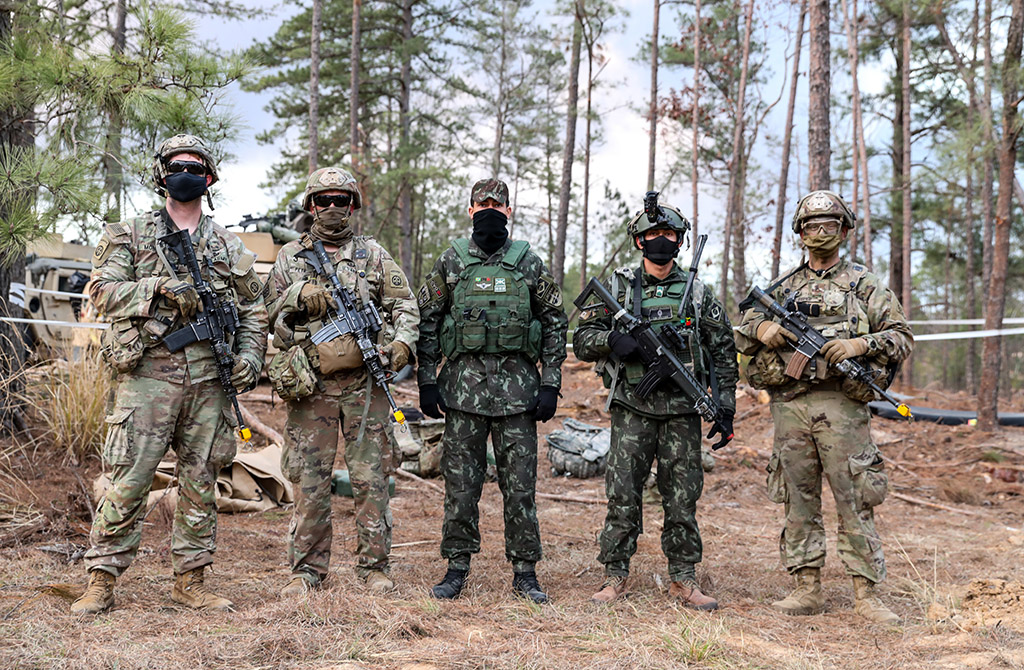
[419,179,567,602]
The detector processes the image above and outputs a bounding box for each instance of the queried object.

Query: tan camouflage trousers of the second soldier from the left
[281,383,397,585]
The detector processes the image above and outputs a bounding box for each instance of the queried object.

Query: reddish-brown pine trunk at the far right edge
[978,0,1024,430]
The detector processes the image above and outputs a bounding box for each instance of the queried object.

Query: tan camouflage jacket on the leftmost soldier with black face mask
[89,209,267,384]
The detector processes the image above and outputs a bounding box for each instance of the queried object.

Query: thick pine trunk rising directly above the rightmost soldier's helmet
[807,0,831,191]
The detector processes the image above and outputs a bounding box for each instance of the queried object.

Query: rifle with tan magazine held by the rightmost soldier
[739,286,913,419]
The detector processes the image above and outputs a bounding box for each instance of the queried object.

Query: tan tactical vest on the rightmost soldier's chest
[776,263,870,380]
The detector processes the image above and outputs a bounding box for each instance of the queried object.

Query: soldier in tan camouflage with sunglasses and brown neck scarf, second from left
[267,167,420,597]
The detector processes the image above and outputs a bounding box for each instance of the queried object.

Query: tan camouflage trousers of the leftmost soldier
[85,376,237,576]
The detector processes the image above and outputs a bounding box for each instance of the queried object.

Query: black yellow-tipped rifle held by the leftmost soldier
[159,231,255,442]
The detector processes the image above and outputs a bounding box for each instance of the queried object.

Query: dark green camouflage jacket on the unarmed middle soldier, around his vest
[418,236,568,416]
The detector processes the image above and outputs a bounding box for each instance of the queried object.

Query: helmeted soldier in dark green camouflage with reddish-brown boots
[572,194,738,610]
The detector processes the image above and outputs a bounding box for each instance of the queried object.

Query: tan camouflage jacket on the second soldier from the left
[267,234,420,395]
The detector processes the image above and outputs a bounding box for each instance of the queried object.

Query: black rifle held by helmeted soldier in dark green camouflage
[573,236,732,446]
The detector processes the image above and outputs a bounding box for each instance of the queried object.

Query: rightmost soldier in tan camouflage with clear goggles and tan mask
[736,191,913,623]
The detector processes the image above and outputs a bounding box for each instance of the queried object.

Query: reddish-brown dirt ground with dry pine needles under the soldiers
[0,358,1024,670]
